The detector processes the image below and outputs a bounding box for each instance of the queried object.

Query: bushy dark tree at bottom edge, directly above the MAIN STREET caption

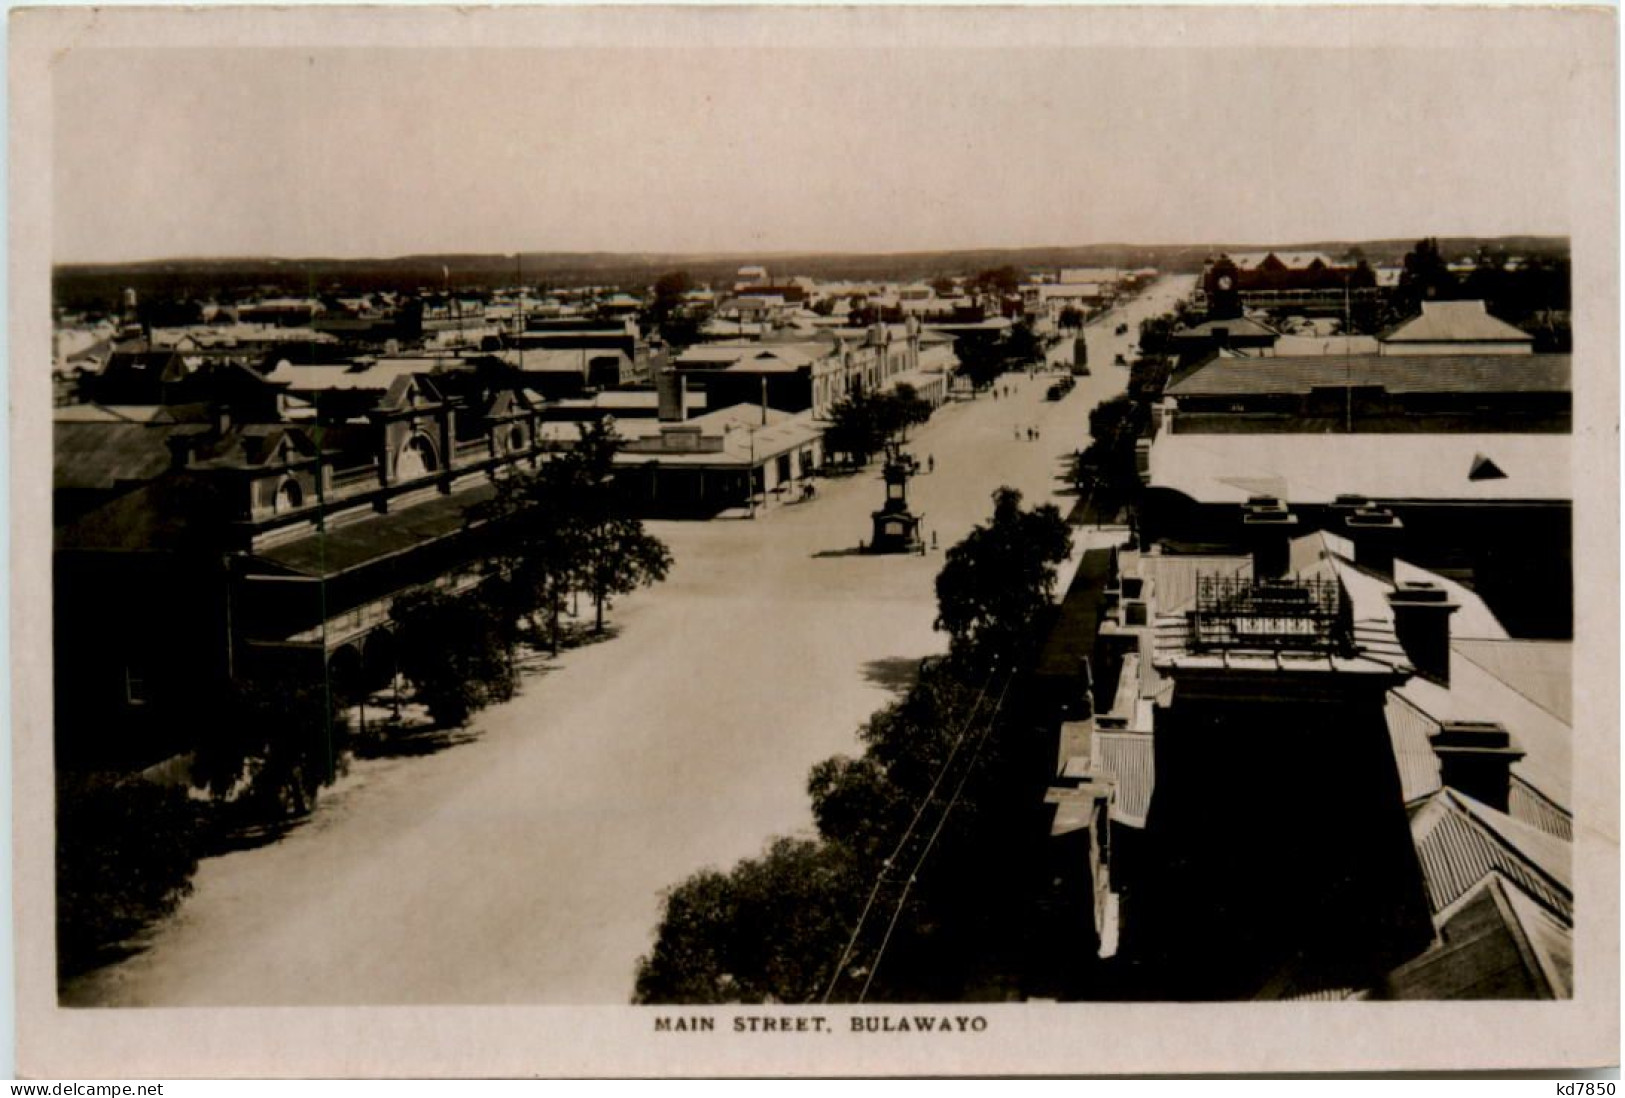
[634,838,868,1004]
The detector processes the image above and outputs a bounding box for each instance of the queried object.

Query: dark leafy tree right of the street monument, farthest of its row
[936,487,1073,668]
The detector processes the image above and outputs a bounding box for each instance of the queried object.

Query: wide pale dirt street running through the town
[68,279,1190,1005]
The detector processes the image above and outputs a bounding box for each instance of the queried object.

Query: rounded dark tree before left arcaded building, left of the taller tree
[390,588,514,728]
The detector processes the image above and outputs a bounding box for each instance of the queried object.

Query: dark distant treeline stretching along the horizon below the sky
[52,237,1568,312]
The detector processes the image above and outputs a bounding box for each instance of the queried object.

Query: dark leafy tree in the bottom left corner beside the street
[57,772,202,976]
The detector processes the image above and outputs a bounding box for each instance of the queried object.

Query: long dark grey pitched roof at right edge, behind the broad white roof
[1167,354,1570,396]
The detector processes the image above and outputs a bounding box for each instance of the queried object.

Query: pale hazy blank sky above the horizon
[52,37,1583,262]
